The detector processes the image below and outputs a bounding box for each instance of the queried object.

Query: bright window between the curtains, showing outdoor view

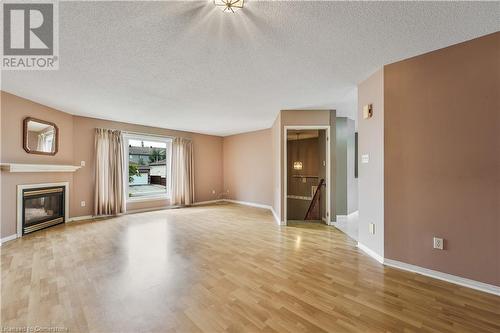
[124,134,171,201]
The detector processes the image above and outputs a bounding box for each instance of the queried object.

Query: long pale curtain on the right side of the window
[171,138,194,206]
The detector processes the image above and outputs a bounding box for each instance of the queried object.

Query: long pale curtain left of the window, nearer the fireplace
[94,128,128,215]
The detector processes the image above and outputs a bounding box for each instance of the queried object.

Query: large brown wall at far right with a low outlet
[384,33,500,285]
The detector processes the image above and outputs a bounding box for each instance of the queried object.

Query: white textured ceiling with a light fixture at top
[2,0,500,135]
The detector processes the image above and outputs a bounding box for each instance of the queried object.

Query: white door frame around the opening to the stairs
[283,125,331,225]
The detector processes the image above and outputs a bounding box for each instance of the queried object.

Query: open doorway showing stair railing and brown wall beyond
[284,126,330,225]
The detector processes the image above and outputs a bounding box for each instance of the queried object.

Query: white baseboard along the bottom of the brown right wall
[384,259,500,296]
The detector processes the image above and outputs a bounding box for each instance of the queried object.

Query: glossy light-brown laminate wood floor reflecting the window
[1,204,500,333]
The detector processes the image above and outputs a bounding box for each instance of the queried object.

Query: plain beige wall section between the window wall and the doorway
[223,129,274,206]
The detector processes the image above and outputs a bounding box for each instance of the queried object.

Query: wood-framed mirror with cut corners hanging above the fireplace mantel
[23,117,59,155]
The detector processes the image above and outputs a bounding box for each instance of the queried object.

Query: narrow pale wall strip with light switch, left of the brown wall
[358,69,384,257]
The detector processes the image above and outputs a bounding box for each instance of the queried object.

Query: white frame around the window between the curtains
[122,132,172,203]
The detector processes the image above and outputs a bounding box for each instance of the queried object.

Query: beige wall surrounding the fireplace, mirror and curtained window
[0,92,223,237]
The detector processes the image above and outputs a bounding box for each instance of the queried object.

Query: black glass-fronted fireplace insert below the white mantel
[22,186,66,235]
